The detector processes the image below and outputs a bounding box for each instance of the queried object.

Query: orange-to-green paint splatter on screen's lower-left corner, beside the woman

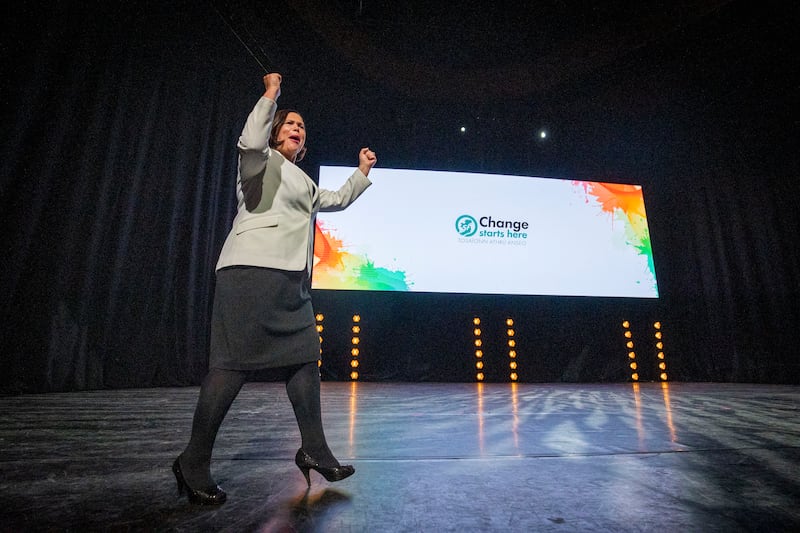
[312,220,411,291]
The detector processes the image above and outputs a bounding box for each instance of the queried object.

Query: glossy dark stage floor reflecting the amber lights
[0,382,800,532]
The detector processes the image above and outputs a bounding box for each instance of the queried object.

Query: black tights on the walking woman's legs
[180,361,339,490]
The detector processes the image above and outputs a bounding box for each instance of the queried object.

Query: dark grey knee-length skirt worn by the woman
[209,266,319,370]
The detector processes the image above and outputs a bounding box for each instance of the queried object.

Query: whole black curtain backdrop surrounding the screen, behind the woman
[0,1,800,392]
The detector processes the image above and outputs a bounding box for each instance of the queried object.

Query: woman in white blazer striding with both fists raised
[172,73,377,505]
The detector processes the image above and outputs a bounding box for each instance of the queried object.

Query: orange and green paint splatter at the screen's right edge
[572,181,658,294]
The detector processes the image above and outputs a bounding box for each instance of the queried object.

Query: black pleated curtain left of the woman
[1,2,259,390]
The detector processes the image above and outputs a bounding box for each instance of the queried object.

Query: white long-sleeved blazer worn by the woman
[217,96,372,272]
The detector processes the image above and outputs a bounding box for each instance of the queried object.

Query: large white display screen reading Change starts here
[312,166,658,298]
